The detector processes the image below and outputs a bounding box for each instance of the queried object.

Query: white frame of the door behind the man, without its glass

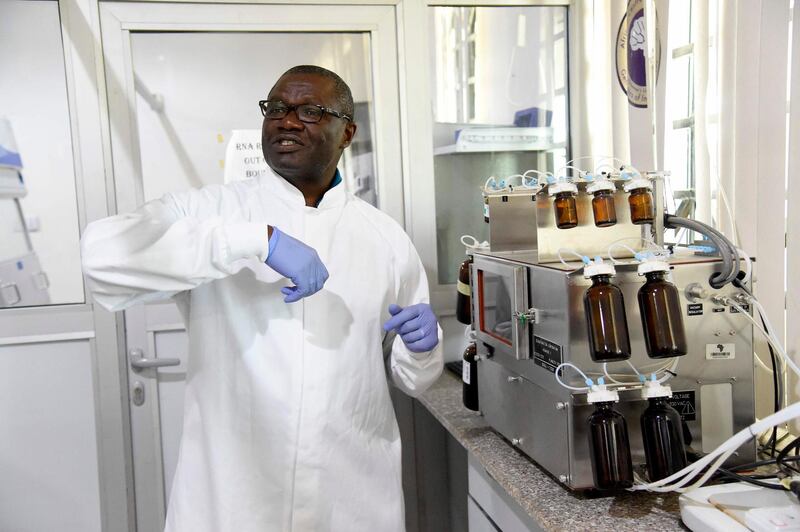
[99,2,406,531]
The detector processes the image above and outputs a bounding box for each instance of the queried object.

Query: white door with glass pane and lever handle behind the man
[100,2,403,532]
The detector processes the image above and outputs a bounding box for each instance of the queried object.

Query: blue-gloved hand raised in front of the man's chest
[266,227,328,303]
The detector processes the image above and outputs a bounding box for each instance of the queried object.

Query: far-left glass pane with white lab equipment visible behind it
[0,0,84,307]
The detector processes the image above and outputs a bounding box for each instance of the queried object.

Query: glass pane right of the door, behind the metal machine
[429,6,569,284]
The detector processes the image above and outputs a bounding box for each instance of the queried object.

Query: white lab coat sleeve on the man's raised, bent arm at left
[81,191,268,311]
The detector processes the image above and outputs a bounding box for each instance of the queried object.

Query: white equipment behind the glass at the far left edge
[0,118,50,307]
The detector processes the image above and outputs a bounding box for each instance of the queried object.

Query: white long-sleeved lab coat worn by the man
[83,170,442,532]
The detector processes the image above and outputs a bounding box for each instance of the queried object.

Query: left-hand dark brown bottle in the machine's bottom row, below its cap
[589,402,633,490]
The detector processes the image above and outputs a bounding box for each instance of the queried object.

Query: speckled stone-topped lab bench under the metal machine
[418,370,687,532]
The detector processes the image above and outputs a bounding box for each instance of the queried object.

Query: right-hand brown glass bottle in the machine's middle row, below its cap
[638,271,687,358]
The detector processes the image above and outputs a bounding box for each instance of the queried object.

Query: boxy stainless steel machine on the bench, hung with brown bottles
[470,165,756,490]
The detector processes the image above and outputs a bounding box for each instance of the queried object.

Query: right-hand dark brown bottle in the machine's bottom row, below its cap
[641,397,686,482]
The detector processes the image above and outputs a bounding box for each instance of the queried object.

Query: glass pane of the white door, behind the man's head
[131,33,377,205]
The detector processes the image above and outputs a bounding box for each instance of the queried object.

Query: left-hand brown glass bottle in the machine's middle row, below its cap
[583,275,631,362]
